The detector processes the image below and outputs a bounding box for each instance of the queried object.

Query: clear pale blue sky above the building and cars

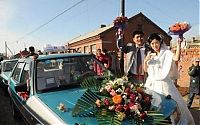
[0,0,200,55]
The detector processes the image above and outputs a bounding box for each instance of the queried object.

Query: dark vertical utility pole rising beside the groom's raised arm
[120,0,125,74]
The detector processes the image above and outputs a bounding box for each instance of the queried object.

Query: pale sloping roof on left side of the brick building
[67,24,114,44]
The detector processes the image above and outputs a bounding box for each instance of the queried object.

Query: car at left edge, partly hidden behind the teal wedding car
[0,59,18,95]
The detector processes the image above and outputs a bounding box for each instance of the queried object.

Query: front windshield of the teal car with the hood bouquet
[36,56,111,92]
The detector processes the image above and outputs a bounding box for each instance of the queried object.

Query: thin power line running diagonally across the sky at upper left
[15,0,85,42]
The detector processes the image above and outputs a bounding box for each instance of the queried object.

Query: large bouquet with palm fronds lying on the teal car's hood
[72,77,170,125]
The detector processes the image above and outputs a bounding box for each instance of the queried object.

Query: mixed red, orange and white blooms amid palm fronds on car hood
[95,77,151,123]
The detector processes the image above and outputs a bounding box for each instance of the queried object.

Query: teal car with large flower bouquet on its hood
[8,53,109,125]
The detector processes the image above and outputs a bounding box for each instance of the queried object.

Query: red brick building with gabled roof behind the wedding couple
[66,13,172,54]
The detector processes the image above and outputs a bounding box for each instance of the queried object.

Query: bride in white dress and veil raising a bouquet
[144,33,195,125]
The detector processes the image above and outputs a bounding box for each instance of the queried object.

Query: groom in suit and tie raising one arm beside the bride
[117,30,150,83]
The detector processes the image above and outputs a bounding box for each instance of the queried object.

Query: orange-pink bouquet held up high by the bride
[169,22,191,36]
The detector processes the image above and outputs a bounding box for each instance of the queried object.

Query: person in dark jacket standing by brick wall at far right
[187,58,200,108]
